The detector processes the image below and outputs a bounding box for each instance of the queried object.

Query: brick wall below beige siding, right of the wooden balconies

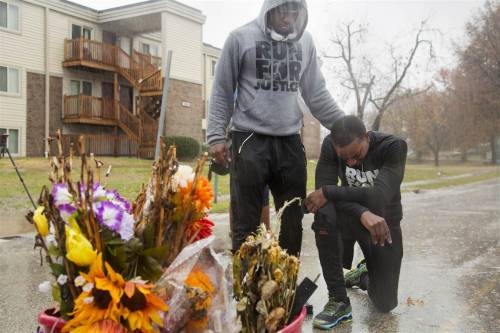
[166,79,204,143]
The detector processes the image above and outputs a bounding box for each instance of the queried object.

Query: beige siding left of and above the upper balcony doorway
[49,11,102,75]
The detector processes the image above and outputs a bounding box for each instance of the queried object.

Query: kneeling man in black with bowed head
[306,116,407,329]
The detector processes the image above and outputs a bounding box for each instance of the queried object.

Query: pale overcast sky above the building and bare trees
[72,0,484,106]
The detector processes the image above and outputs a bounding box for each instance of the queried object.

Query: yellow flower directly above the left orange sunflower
[66,227,97,266]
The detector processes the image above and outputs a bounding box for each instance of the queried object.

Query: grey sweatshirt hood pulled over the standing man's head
[257,0,308,41]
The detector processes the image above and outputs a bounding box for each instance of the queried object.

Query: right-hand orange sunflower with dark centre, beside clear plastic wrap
[121,280,168,333]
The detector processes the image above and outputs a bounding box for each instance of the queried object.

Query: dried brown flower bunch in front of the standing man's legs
[233,199,300,333]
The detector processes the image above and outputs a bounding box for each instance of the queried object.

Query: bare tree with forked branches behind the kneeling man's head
[324,21,434,131]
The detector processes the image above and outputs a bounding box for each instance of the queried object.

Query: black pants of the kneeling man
[313,203,403,312]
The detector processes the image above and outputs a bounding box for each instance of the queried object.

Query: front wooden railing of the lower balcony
[63,95,116,122]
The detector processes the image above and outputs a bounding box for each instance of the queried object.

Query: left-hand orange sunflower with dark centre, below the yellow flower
[63,253,125,332]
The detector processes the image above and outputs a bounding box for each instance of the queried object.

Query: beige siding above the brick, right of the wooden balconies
[162,13,203,83]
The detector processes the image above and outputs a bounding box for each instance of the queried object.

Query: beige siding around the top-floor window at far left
[0,2,45,72]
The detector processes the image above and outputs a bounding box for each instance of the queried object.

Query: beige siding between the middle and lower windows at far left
[0,68,26,156]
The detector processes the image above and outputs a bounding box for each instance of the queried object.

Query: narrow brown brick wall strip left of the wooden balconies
[26,72,45,156]
